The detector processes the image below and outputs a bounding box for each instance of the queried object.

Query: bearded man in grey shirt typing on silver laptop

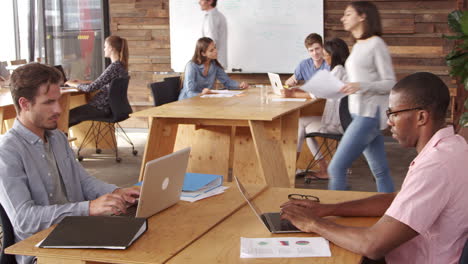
[0,63,140,263]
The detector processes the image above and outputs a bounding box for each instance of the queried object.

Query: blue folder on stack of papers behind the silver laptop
[180,172,227,202]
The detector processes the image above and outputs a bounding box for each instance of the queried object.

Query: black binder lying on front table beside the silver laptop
[39,216,148,249]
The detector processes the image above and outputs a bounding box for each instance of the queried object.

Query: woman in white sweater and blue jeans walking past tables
[328,1,396,192]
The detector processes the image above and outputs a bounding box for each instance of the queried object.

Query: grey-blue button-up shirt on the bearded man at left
[0,120,117,263]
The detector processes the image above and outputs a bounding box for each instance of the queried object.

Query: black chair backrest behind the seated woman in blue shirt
[150,77,180,106]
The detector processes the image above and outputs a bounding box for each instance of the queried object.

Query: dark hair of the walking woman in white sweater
[349,1,382,39]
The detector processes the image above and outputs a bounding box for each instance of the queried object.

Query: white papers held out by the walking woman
[301,70,346,99]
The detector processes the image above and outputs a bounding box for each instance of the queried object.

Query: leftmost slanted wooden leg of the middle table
[139,117,178,181]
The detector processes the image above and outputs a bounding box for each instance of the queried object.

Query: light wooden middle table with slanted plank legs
[132,88,323,187]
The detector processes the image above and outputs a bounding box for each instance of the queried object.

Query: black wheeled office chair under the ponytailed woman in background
[77,78,138,162]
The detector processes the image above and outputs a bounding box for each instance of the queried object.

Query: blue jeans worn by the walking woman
[328,114,394,192]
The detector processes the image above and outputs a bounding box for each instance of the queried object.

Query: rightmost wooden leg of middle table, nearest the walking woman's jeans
[280,110,300,188]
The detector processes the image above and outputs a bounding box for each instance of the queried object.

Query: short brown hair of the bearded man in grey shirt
[10,63,63,113]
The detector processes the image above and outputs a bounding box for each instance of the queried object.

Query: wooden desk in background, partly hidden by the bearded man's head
[0,90,75,133]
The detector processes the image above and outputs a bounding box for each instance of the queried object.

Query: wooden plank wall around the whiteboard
[109,0,466,127]
